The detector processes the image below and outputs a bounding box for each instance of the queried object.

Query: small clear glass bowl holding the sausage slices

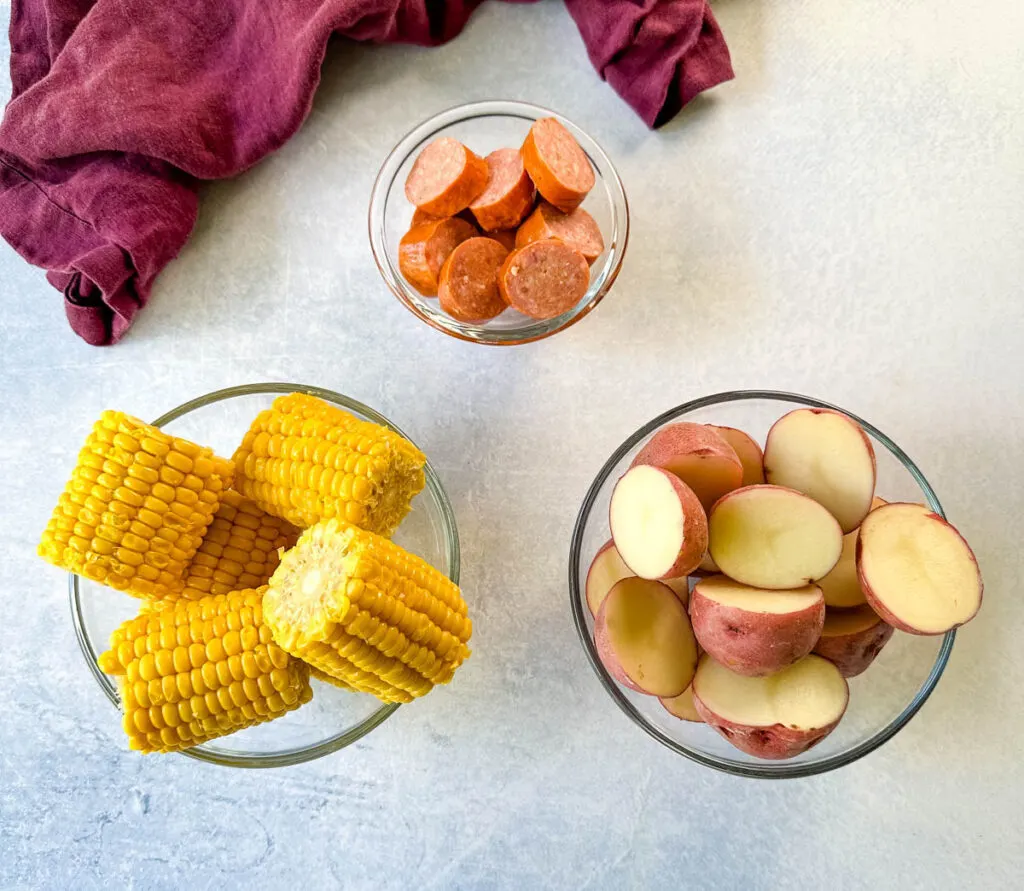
[370,100,630,345]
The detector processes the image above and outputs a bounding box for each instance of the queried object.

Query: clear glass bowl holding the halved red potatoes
[569,390,955,778]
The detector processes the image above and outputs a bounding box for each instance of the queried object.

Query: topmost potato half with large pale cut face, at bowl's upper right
[764,409,876,533]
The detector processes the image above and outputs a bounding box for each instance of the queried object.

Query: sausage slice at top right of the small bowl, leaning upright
[519,118,594,213]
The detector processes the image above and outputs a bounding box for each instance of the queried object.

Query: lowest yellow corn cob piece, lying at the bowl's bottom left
[98,587,312,753]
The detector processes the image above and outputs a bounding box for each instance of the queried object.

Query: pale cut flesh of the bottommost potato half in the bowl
[693,655,849,730]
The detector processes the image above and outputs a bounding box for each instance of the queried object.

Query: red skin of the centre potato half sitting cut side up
[690,585,825,677]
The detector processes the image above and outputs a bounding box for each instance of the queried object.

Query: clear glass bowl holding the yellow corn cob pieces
[69,383,459,767]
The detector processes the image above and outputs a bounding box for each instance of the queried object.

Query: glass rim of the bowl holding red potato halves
[568,390,956,779]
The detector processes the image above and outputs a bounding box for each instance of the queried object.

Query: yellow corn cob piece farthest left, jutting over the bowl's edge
[39,412,233,598]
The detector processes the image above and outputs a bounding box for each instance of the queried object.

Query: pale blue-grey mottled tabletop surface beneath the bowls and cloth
[0,0,1024,891]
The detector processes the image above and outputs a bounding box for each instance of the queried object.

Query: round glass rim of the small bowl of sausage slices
[368,99,630,346]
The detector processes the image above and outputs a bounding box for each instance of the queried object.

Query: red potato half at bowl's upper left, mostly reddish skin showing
[631,421,743,513]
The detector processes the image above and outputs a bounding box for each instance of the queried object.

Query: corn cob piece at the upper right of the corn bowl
[233,393,426,537]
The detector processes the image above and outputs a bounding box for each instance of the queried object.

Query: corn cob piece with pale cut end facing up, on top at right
[263,519,472,703]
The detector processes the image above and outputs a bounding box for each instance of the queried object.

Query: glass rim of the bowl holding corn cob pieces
[68,382,461,769]
